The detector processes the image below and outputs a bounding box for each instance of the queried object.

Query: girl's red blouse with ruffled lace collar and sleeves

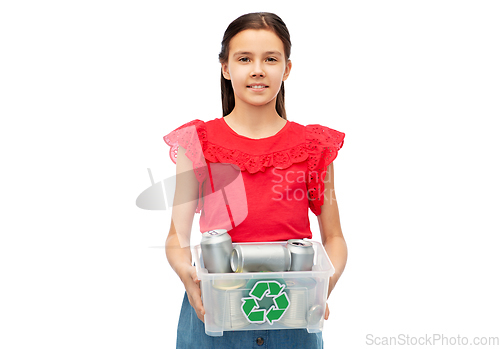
[164,118,345,242]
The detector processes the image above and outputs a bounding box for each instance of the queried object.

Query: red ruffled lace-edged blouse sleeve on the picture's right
[306,125,345,216]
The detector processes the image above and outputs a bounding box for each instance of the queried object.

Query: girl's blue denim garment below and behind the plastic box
[177,293,323,349]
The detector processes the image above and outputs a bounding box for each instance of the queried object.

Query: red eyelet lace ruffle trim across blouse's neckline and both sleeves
[163,120,345,215]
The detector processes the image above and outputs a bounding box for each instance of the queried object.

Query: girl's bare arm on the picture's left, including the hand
[165,147,205,321]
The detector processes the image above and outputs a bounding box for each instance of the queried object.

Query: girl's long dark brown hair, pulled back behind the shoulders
[219,12,292,120]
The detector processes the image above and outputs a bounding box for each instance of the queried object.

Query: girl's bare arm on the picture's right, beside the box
[318,163,347,318]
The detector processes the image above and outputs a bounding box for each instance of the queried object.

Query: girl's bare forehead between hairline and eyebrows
[229,29,285,54]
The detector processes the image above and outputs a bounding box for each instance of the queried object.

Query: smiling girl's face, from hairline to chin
[222,29,292,110]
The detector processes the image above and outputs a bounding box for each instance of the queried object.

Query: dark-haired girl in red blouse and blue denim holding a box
[164,13,347,349]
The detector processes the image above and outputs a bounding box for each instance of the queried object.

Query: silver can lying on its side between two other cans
[231,244,292,273]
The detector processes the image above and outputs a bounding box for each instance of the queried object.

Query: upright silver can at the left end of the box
[200,229,233,273]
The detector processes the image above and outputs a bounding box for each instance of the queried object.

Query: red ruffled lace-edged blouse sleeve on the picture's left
[163,120,207,213]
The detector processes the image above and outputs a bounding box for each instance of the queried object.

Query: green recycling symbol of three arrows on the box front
[241,280,290,325]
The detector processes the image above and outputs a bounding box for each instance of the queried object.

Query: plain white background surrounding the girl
[0,0,500,349]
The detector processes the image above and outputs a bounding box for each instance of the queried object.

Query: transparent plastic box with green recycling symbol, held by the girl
[192,241,335,336]
